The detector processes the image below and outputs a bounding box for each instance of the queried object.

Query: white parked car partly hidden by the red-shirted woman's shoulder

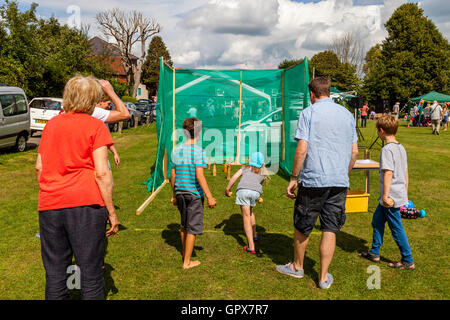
[30,98,62,136]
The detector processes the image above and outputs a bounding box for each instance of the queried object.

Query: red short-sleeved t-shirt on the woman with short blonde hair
[38,113,114,211]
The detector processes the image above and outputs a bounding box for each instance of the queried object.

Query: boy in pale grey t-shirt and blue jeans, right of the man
[360,115,416,270]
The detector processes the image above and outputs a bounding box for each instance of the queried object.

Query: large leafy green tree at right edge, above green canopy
[364,3,450,102]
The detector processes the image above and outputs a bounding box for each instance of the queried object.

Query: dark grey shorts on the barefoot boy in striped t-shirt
[176,193,204,234]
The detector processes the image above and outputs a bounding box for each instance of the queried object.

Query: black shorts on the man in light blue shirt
[294,185,347,236]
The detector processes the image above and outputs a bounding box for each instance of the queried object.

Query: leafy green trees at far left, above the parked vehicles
[0,0,109,97]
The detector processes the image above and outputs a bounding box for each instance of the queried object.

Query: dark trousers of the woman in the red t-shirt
[39,206,108,300]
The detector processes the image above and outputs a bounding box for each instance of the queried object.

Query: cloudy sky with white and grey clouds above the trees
[5,0,450,68]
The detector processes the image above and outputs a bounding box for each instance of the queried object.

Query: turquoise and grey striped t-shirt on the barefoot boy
[171,144,207,197]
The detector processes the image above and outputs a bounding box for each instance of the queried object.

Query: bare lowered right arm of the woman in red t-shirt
[92,146,119,237]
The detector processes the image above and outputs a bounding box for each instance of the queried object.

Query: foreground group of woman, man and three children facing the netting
[36,76,415,299]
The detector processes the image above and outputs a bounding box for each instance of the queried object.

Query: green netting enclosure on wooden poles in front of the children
[143,58,310,198]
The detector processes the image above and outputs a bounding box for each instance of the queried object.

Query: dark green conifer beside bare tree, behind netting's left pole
[141,36,173,96]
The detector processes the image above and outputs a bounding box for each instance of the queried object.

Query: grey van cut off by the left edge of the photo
[0,86,30,152]
